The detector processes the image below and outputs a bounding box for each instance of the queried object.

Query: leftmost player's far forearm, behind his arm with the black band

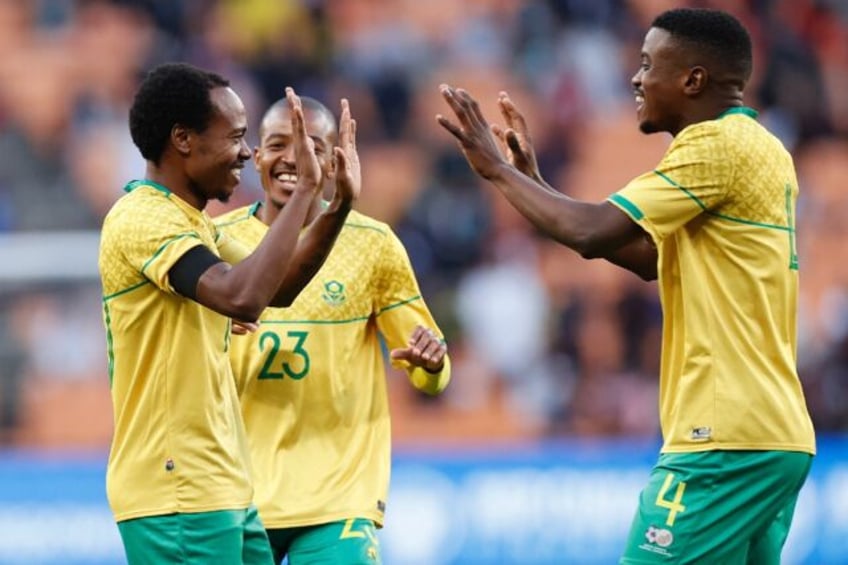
[271,196,352,306]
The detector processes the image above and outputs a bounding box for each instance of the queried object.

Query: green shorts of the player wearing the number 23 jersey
[268,518,382,565]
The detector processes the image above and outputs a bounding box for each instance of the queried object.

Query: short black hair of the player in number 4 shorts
[651,8,754,84]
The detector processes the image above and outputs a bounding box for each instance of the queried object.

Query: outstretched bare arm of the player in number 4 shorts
[437,85,656,276]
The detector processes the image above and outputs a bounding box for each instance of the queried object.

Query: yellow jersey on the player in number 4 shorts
[609,108,815,454]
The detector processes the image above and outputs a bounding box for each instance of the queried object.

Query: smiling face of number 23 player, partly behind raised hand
[253,107,336,207]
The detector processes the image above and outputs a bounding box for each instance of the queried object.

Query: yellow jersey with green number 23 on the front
[216,203,450,529]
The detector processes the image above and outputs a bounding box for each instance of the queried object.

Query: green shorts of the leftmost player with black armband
[118,506,273,565]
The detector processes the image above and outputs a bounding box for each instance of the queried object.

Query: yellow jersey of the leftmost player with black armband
[99,181,253,522]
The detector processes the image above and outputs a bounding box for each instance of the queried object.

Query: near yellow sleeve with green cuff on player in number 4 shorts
[608,122,734,242]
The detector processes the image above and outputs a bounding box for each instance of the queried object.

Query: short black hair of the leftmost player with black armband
[130,63,230,165]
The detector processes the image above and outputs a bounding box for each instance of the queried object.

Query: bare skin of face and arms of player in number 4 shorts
[436,28,745,280]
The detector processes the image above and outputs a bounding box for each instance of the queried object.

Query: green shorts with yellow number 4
[620,451,813,565]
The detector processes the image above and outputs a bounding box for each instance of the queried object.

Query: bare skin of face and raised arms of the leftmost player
[146,87,359,322]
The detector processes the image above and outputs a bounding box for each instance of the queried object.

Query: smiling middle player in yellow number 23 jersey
[216,94,450,565]
